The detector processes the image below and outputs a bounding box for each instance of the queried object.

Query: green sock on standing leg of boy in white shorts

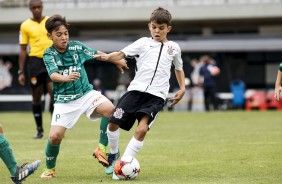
[45,140,60,169]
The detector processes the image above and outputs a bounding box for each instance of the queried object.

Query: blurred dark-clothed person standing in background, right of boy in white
[200,55,220,111]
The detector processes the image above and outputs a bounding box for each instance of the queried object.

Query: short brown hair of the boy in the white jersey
[150,7,171,26]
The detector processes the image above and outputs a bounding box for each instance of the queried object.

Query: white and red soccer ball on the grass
[114,156,140,180]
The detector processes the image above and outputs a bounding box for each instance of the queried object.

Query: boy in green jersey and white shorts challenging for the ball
[41,15,127,179]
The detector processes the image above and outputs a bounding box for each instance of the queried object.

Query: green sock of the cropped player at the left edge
[0,135,18,176]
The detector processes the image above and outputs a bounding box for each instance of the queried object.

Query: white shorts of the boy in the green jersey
[51,90,109,128]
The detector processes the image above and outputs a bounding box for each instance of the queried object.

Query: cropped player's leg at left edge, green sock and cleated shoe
[0,124,41,184]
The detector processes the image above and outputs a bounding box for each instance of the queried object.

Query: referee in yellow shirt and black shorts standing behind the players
[18,0,53,139]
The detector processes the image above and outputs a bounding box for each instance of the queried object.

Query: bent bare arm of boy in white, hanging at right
[169,70,185,105]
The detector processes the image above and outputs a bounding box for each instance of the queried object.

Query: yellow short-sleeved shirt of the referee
[19,16,52,58]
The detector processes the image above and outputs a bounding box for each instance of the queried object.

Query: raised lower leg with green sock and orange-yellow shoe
[93,116,109,166]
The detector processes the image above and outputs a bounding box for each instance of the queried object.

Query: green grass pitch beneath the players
[0,111,282,184]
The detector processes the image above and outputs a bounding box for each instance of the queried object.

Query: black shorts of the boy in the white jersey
[110,91,165,131]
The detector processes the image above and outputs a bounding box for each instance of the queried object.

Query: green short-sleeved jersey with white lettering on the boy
[43,41,97,103]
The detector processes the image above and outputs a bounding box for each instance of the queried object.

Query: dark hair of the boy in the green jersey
[45,15,69,33]
